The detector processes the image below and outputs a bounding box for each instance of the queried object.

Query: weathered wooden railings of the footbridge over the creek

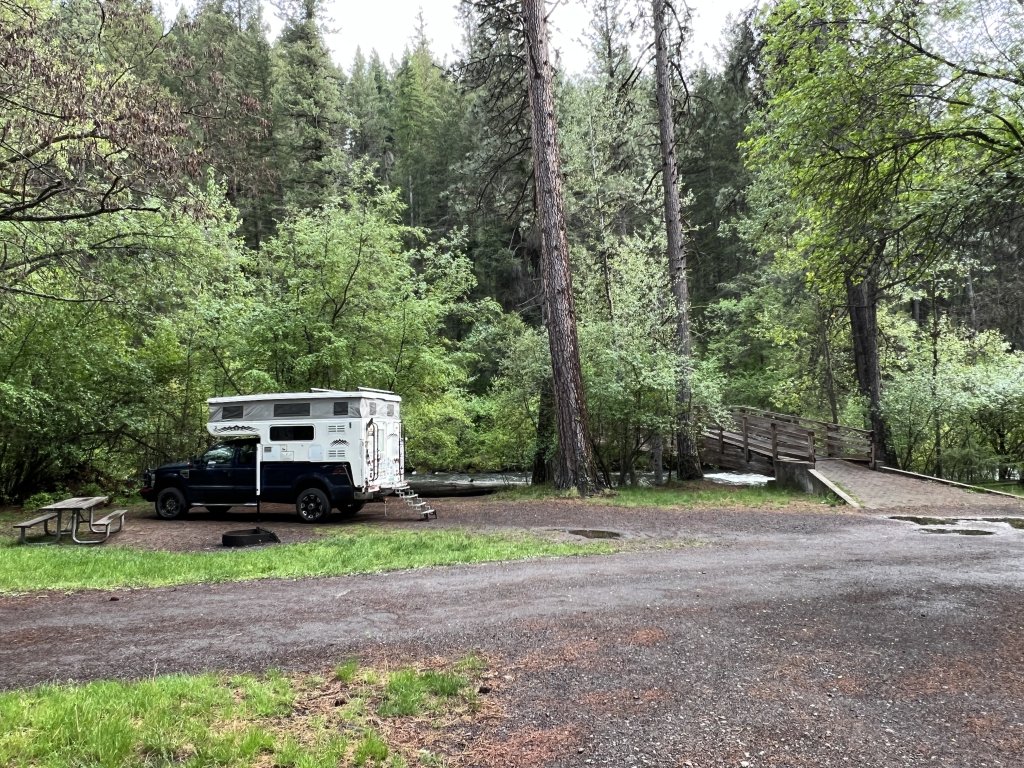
[705,407,874,464]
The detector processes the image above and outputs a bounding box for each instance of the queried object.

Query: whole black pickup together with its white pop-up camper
[140,387,408,522]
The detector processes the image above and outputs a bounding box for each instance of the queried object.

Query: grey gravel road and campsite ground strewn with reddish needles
[0,499,1024,768]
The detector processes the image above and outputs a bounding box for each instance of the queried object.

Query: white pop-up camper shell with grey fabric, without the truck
[206,387,408,500]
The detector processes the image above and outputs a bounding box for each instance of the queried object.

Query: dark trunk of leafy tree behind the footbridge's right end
[846,275,895,464]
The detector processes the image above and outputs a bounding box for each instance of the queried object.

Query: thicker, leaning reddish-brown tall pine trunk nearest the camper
[522,0,602,495]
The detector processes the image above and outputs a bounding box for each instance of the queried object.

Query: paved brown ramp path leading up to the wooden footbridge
[814,459,1024,514]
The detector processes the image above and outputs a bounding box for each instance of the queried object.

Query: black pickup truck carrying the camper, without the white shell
[139,439,364,522]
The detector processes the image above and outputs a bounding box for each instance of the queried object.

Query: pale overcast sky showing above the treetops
[284,0,754,74]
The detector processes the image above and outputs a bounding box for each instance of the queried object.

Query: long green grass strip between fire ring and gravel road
[0,527,613,594]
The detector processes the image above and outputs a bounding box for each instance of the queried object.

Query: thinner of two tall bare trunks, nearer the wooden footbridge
[653,0,703,480]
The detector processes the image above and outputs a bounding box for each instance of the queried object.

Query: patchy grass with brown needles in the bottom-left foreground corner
[0,664,491,768]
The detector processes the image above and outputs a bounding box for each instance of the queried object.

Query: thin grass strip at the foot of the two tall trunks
[496,480,826,508]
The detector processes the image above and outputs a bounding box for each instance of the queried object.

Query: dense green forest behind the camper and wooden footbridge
[0,0,1024,502]
